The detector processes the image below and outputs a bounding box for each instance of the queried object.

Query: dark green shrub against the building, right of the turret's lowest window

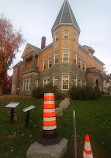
[69,86,100,100]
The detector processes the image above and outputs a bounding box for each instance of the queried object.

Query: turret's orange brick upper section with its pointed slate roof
[52,0,80,63]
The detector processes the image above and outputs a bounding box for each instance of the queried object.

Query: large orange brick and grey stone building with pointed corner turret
[12,0,106,95]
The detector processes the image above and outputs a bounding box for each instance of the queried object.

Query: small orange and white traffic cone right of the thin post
[83,134,93,158]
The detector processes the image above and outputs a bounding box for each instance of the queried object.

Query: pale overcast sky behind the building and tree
[0,0,111,74]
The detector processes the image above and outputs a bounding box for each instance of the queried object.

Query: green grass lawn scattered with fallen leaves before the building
[0,97,111,158]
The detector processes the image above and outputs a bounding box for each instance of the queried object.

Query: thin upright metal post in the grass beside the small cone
[73,110,77,158]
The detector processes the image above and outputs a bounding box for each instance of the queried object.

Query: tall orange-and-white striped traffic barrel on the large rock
[43,93,57,138]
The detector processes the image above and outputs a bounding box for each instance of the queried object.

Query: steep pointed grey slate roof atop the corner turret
[52,0,80,32]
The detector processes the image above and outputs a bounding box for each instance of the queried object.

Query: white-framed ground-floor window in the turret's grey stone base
[62,75,69,90]
